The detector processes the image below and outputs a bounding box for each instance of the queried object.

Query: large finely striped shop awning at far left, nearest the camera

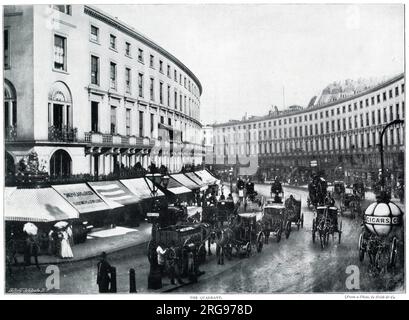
[4,188,79,222]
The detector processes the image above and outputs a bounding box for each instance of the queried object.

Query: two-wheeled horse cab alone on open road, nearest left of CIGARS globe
[312,206,342,249]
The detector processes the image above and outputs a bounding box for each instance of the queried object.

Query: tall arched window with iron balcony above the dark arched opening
[48,81,72,141]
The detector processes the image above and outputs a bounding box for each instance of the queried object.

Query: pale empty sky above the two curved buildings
[98,4,404,124]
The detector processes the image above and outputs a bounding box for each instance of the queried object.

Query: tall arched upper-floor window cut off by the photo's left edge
[4,79,17,139]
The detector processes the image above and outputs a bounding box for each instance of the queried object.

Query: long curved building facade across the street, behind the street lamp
[213,74,405,182]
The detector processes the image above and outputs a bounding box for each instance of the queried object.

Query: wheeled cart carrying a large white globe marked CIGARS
[358,201,403,274]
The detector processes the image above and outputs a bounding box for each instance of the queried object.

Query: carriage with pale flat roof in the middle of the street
[261,203,291,243]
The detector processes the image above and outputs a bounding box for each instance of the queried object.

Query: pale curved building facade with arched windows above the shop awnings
[4,5,202,176]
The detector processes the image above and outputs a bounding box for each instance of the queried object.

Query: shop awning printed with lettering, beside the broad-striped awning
[52,183,111,213]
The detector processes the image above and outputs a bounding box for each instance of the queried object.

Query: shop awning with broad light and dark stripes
[88,181,139,208]
